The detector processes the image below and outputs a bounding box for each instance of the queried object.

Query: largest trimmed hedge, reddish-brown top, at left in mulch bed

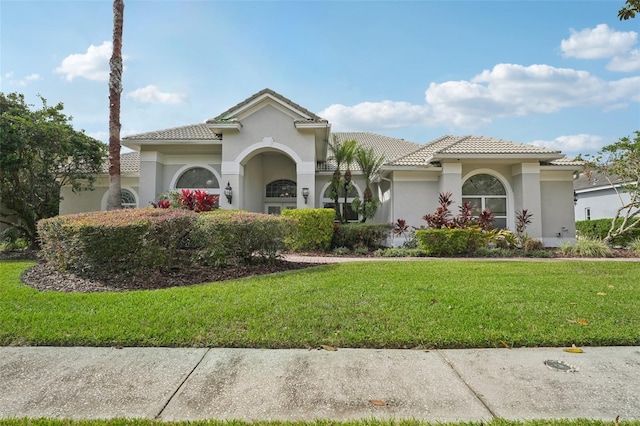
[38,209,196,274]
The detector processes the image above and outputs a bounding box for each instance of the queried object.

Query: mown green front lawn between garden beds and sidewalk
[0,260,640,348]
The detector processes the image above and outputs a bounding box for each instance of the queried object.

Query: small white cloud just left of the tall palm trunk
[55,41,112,81]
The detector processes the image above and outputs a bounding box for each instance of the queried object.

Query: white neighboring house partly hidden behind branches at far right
[573,172,631,220]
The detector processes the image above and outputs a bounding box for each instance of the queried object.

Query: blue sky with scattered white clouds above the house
[0,0,640,156]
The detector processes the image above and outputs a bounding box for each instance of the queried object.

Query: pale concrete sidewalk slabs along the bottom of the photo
[0,347,640,422]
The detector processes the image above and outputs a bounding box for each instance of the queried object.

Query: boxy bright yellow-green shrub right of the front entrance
[282,209,336,251]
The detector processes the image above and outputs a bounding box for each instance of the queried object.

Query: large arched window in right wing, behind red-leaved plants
[462,173,507,229]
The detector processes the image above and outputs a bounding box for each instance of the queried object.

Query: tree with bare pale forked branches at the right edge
[587,130,640,242]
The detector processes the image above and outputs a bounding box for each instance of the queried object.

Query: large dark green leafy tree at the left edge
[0,93,106,244]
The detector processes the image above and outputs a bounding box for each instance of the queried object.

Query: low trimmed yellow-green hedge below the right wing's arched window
[416,228,482,256]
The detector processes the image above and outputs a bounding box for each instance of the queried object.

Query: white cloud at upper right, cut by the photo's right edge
[560,24,640,72]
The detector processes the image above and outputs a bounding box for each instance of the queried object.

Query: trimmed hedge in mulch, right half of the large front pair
[191,210,296,266]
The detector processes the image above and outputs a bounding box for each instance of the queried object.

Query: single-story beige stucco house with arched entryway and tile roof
[60,89,581,246]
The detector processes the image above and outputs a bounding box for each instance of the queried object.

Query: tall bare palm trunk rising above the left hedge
[107,0,124,210]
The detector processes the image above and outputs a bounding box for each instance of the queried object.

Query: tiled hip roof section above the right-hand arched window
[393,135,560,166]
